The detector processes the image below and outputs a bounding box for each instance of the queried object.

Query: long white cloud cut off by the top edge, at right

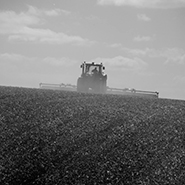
[98,0,185,9]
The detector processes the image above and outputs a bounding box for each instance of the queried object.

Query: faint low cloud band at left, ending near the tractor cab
[0,53,77,78]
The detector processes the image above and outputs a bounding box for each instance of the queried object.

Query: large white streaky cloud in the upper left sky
[0,6,94,46]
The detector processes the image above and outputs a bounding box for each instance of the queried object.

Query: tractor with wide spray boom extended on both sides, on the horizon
[40,62,159,98]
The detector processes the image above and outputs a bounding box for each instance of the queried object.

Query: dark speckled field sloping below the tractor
[0,86,185,185]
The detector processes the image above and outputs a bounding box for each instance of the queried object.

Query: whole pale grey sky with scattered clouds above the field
[0,0,185,100]
